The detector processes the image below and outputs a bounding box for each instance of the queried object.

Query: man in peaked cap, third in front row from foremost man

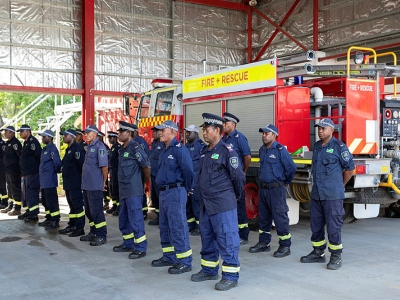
[113,121,150,259]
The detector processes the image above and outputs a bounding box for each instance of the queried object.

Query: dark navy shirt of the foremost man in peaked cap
[199,141,246,215]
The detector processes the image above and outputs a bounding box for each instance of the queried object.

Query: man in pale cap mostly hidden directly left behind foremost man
[185,125,205,236]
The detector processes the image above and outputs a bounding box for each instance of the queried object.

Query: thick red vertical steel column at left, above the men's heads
[82,0,95,129]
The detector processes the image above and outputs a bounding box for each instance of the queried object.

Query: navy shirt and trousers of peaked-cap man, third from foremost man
[118,140,150,252]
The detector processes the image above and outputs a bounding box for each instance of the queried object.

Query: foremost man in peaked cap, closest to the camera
[191,113,246,291]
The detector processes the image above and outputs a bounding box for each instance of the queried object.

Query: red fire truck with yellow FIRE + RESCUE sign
[130,46,400,224]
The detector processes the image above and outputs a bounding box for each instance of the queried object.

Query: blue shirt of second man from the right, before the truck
[258,141,297,184]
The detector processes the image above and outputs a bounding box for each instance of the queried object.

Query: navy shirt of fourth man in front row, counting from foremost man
[82,138,108,191]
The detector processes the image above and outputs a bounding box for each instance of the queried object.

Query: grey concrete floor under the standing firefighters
[0,198,400,300]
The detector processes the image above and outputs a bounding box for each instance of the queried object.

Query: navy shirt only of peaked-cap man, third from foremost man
[118,140,150,199]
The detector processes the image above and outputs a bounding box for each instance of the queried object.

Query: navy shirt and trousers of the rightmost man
[310,137,354,253]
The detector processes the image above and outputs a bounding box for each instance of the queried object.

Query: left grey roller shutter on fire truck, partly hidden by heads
[185,101,221,129]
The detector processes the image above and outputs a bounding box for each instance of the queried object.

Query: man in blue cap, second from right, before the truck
[249,124,296,258]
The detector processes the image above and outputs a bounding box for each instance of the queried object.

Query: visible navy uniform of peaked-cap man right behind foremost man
[222,129,251,241]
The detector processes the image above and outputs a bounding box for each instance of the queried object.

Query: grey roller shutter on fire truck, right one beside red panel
[226,94,274,156]
